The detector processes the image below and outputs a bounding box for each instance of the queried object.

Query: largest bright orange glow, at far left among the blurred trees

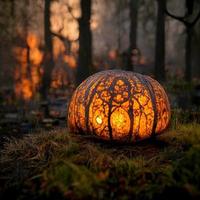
[13,33,43,101]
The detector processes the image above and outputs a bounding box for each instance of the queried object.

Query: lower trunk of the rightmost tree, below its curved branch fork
[185,26,192,83]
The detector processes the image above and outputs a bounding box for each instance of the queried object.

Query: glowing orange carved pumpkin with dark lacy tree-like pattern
[68,70,170,142]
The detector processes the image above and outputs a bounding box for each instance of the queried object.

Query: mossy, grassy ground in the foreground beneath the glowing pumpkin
[0,123,200,200]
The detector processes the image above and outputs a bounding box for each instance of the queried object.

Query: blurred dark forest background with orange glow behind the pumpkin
[0,0,200,134]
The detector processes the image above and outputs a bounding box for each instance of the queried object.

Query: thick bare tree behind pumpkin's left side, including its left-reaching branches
[48,0,93,84]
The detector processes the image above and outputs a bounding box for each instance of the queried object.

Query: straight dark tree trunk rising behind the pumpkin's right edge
[155,0,166,81]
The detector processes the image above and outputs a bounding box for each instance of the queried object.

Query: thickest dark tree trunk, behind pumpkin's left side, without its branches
[76,0,92,84]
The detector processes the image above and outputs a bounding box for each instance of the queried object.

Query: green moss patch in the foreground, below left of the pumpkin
[41,161,98,198]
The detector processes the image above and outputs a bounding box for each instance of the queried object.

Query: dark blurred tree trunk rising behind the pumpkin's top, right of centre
[126,0,139,71]
